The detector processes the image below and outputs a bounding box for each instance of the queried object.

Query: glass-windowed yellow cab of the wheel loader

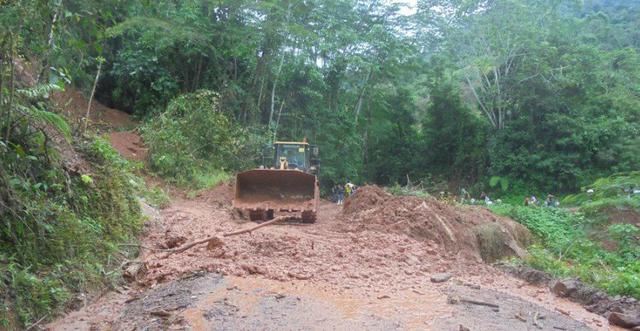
[263,141,320,174]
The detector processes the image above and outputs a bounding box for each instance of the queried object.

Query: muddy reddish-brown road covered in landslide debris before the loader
[47,185,609,330]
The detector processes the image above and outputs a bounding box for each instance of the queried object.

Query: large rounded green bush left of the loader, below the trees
[142,90,264,186]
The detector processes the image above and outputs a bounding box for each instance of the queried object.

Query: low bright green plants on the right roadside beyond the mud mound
[491,196,640,298]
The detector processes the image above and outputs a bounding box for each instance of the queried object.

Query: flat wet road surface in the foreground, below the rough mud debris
[51,273,591,330]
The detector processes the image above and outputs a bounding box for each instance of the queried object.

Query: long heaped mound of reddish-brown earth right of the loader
[338,186,530,262]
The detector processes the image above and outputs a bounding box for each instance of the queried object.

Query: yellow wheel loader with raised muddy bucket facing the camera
[233,138,320,223]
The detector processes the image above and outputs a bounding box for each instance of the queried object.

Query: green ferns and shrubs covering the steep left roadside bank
[0,138,142,327]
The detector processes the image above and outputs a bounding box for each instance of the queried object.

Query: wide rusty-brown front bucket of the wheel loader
[233,169,319,213]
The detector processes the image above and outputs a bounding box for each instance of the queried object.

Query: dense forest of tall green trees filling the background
[3,0,640,191]
